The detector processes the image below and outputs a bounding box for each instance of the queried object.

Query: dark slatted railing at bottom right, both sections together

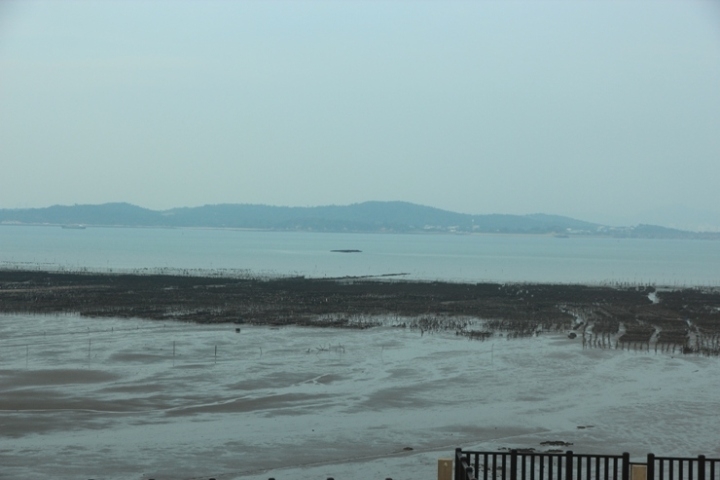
[454,448,720,480]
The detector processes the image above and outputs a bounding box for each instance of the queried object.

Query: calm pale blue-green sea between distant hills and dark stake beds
[0,226,720,286]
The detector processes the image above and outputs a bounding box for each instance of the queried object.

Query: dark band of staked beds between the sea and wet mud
[0,270,720,355]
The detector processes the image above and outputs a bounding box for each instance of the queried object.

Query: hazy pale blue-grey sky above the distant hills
[0,0,720,229]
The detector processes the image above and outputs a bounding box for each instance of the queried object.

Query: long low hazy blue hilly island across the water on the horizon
[0,202,720,240]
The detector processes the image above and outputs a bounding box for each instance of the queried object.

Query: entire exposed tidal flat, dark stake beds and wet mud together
[0,271,720,480]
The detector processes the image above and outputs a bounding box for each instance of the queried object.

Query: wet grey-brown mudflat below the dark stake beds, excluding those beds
[0,314,720,480]
